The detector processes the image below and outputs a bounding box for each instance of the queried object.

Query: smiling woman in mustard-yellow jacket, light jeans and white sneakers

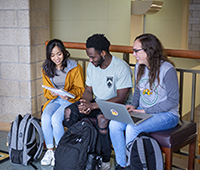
[41,39,84,166]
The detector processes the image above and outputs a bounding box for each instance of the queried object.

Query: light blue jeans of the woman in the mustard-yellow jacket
[41,96,71,148]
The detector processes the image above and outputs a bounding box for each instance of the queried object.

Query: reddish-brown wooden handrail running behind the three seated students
[45,41,200,59]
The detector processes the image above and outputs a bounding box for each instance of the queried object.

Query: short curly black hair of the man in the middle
[86,34,110,53]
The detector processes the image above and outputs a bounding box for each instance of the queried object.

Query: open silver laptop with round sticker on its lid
[96,99,152,125]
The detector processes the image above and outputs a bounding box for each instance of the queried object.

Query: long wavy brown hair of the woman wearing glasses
[135,34,174,90]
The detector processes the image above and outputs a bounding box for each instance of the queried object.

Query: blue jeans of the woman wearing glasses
[109,112,179,167]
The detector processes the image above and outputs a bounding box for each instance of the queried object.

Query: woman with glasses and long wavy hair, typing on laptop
[109,34,179,170]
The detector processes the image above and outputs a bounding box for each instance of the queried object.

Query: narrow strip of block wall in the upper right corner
[188,0,200,51]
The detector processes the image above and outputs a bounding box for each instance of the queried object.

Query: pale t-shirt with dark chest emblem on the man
[86,56,133,100]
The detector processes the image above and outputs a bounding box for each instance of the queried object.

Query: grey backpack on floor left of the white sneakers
[8,113,44,165]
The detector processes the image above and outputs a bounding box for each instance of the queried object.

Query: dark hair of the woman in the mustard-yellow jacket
[42,39,70,78]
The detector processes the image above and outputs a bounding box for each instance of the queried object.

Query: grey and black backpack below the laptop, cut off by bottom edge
[126,133,164,170]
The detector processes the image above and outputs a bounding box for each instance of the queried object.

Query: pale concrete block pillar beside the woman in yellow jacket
[0,0,50,123]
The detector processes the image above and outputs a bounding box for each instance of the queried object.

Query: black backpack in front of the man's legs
[54,119,100,170]
